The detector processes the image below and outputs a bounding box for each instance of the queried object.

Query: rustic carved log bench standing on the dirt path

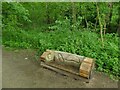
[40,50,94,79]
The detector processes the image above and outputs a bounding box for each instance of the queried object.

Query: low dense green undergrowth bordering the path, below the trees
[2,29,120,77]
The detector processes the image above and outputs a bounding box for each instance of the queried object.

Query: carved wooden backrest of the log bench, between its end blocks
[47,50,85,67]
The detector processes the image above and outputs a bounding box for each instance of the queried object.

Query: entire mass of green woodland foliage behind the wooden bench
[0,2,120,77]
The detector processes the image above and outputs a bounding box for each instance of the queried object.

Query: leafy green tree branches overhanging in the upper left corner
[2,2,30,29]
